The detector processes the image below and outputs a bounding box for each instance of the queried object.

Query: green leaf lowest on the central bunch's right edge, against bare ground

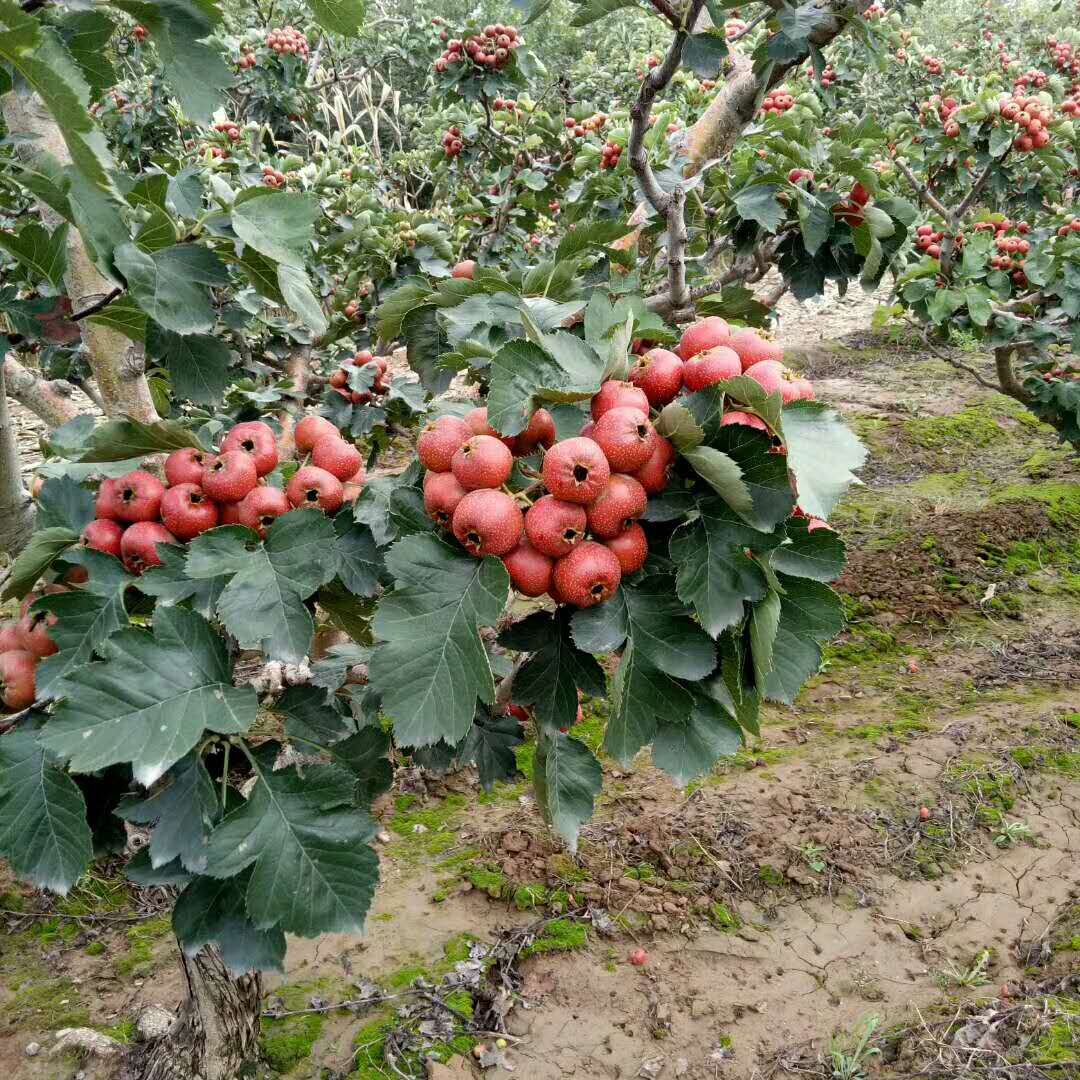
[762,575,843,705]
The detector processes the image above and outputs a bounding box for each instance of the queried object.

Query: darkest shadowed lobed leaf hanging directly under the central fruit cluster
[499,610,606,729]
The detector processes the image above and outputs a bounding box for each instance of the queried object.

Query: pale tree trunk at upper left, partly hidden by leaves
[2,93,159,423]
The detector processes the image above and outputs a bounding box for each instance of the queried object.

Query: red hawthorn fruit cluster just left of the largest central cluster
[75,415,365,573]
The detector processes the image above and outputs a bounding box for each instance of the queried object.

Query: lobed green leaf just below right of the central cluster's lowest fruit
[572,575,716,680]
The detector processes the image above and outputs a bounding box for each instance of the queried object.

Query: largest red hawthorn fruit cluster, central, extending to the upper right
[417,316,813,608]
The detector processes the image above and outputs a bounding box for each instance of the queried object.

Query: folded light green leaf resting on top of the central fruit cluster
[487,334,604,435]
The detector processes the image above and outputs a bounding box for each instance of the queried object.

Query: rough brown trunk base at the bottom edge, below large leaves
[127,946,262,1080]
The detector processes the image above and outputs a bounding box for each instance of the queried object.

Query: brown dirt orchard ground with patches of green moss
[0,282,1080,1080]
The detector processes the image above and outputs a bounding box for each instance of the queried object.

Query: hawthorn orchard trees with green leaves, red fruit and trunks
[0,0,1080,1077]
